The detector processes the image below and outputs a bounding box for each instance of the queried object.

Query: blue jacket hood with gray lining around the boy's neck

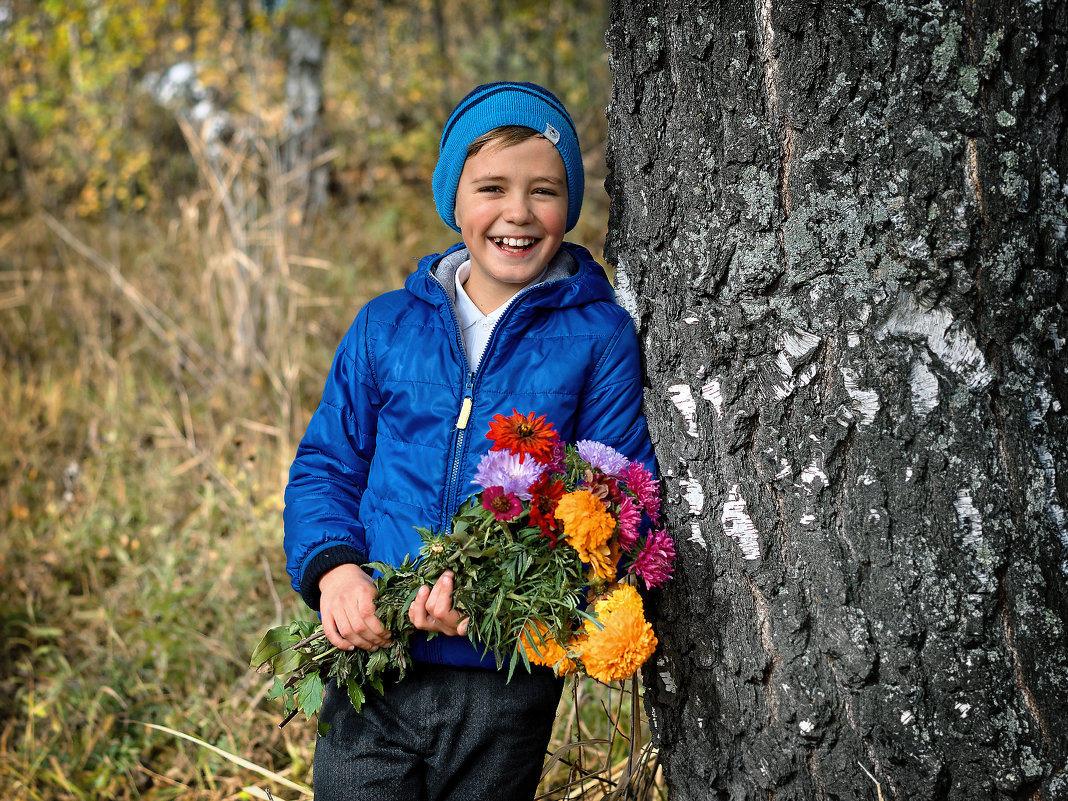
[405,242,615,309]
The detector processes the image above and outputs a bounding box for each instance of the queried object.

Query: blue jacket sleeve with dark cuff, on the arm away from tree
[283,308,381,610]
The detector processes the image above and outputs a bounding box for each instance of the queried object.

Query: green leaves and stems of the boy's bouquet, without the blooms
[251,502,585,720]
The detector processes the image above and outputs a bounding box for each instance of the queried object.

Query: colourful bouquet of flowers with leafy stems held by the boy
[252,410,675,725]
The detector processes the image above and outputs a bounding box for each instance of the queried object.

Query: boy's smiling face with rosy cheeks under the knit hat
[455,137,567,314]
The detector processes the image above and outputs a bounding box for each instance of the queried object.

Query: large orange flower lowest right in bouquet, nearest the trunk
[582,584,657,681]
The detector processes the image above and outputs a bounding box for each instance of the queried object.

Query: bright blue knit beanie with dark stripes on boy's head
[434,82,585,231]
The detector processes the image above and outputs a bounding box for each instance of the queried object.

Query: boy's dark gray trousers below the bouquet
[313,663,564,801]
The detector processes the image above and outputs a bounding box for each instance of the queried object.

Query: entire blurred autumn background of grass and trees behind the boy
[0,0,657,801]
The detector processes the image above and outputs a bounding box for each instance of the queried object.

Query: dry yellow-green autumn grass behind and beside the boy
[0,147,660,801]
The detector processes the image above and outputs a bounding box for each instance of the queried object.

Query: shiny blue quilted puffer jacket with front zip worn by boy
[284,244,654,666]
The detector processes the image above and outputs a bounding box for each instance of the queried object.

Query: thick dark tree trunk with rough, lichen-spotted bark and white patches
[607,0,1068,801]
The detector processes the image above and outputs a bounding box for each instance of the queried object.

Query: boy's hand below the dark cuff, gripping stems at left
[319,565,390,650]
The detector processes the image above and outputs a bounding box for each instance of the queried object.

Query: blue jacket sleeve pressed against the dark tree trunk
[576,310,657,475]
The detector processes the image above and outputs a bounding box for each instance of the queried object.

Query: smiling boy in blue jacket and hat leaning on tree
[285,82,653,801]
